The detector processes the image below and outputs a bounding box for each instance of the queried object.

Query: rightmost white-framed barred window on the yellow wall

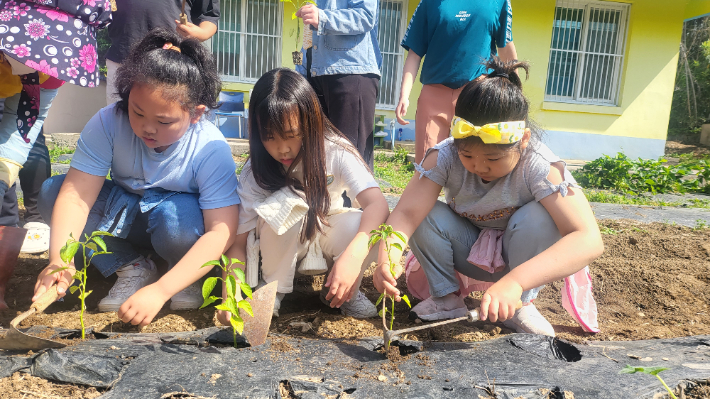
[545,0,630,106]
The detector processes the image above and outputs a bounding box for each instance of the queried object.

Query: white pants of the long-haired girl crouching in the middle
[258,210,377,294]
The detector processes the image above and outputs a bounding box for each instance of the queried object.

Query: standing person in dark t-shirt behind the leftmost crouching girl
[106,0,219,105]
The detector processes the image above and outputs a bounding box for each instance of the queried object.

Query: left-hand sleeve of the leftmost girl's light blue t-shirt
[71,107,114,177]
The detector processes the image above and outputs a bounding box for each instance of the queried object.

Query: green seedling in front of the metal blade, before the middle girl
[200,255,254,348]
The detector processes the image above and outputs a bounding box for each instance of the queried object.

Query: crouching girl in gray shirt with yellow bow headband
[374,57,604,336]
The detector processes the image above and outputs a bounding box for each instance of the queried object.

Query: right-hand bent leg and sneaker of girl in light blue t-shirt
[140,193,205,310]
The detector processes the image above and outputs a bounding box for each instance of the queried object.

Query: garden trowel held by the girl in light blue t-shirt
[0,285,66,351]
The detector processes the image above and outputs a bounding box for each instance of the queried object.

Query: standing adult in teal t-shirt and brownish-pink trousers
[395,0,518,163]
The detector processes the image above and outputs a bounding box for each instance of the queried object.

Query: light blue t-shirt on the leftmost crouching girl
[71,104,240,209]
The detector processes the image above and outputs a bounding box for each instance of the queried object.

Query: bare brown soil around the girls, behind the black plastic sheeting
[0,221,710,398]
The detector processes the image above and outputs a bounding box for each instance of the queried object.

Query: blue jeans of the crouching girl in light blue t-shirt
[38,175,205,277]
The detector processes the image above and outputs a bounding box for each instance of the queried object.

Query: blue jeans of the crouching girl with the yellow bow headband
[409,201,561,303]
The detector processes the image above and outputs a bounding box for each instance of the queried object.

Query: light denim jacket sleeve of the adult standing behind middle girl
[318,0,377,35]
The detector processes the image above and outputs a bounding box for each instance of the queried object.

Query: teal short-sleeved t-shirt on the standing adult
[401,0,513,89]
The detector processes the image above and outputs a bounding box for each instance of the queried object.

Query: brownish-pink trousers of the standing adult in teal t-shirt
[414,84,458,163]
